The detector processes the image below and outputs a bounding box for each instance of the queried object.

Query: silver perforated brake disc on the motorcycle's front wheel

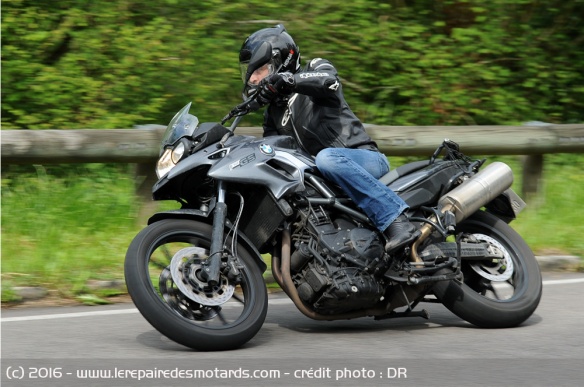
[170,247,235,306]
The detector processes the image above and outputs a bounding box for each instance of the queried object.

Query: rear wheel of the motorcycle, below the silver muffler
[433,212,542,328]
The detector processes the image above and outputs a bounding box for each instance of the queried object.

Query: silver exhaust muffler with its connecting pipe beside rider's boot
[411,161,513,262]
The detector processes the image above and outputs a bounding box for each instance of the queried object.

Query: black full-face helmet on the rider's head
[239,24,300,98]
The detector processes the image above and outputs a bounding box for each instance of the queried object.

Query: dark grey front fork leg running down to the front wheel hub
[202,181,227,286]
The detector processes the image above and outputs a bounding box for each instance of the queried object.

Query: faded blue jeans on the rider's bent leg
[316,148,408,232]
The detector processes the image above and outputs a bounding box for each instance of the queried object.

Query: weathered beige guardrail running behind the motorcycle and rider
[0,124,584,200]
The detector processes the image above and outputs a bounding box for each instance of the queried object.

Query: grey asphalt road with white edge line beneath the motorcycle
[1,273,584,386]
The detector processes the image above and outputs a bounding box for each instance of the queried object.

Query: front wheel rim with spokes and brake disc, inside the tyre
[145,232,255,329]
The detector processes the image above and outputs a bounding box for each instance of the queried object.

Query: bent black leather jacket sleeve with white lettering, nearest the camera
[294,58,341,99]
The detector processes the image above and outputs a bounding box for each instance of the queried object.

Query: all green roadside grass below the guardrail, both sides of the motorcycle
[2,155,584,303]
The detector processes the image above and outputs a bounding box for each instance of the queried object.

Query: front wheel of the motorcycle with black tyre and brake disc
[124,219,268,351]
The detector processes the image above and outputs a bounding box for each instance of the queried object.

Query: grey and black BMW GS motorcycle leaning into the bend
[125,97,542,350]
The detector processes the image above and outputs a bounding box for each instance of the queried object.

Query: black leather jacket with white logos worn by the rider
[263,58,377,156]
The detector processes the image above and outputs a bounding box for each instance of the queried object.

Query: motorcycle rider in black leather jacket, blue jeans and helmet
[239,24,419,252]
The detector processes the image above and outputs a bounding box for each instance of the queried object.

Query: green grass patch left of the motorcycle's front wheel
[2,164,140,301]
